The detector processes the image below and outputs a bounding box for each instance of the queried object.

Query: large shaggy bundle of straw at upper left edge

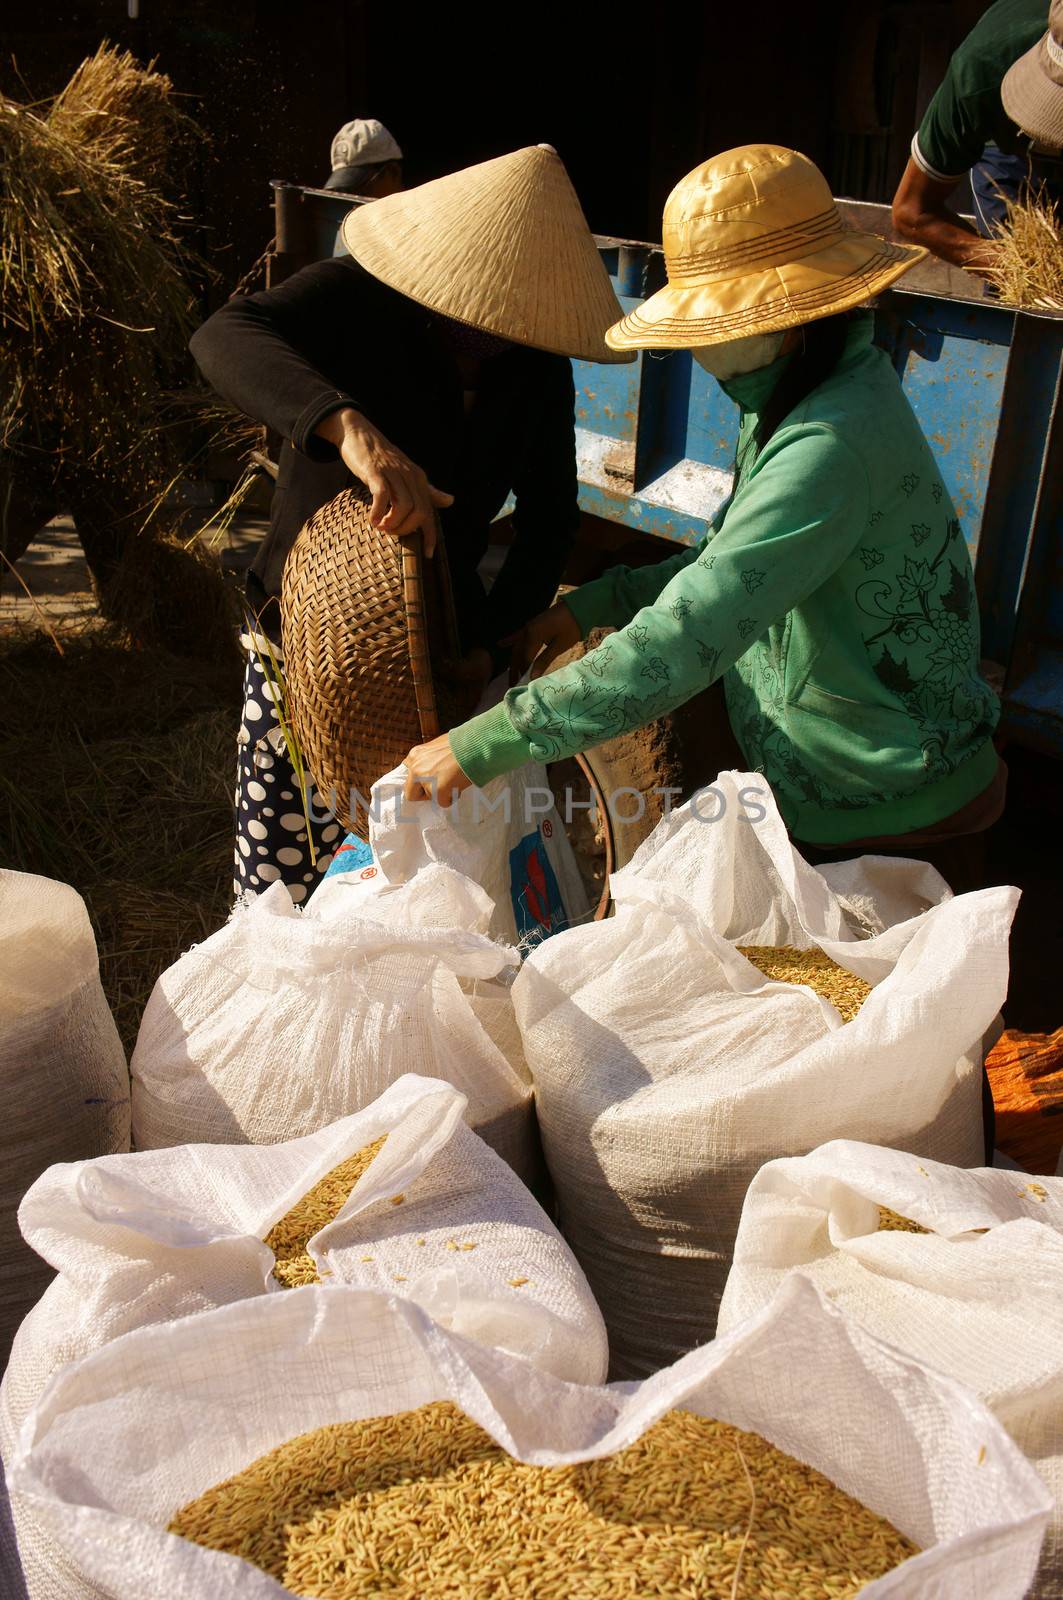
[0,45,244,653]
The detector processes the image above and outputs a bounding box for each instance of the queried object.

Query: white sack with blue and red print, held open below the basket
[307,762,591,949]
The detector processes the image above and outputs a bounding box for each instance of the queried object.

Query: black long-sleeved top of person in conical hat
[191,258,580,650]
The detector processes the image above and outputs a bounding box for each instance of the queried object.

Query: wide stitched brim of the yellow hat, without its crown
[605,230,927,350]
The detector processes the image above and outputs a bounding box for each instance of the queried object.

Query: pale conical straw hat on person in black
[343,144,632,362]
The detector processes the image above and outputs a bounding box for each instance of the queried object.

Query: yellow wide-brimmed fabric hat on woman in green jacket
[605,144,927,350]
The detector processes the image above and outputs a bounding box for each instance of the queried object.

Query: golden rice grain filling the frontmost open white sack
[170,1402,916,1600]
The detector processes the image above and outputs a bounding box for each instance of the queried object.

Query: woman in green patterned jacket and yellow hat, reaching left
[407,146,1004,859]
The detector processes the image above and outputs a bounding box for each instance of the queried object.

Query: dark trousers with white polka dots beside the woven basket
[232,635,344,906]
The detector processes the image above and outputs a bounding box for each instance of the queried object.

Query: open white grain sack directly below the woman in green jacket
[512,773,1018,1378]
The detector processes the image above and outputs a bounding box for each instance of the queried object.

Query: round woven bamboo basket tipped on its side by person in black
[280,488,459,838]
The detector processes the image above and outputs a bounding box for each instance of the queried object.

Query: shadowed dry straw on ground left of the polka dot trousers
[0,624,240,1050]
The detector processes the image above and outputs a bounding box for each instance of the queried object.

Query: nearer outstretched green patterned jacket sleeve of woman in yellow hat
[450,424,868,784]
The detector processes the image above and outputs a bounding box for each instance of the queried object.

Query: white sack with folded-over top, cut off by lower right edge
[720,1139,1063,1600]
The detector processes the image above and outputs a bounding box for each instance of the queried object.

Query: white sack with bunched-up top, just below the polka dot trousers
[133,866,535,1173]
